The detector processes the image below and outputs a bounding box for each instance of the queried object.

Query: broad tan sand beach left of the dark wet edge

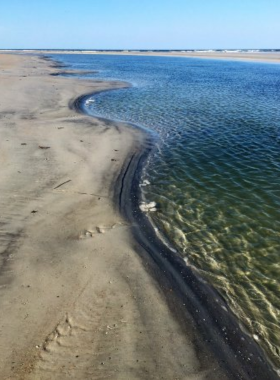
[0,54,230,380]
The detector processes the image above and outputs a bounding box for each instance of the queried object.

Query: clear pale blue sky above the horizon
[0,0,280,49]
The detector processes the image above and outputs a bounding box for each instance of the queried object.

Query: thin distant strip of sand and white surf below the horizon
[0,49,280,63]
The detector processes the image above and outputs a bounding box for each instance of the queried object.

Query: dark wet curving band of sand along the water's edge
[72,70,280,380]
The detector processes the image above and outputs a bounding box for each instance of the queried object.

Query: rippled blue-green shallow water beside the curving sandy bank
[54,55,280,367]
